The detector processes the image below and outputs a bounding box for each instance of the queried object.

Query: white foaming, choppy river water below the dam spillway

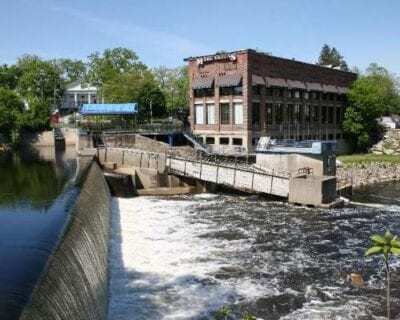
[109,183,400,320]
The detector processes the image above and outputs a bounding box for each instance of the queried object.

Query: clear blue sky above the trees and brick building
[0,0,400,75]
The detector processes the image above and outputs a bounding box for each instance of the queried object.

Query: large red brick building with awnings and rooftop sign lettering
[185,50,357,151]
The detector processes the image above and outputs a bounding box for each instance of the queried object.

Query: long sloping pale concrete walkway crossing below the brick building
[98,148,289,198]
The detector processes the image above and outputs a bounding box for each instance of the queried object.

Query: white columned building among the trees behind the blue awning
[61,82,104,111]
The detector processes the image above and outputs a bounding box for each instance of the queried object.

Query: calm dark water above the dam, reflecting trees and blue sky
[0,148,77,320]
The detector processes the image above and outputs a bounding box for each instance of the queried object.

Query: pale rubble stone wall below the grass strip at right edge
[336,162,400,187]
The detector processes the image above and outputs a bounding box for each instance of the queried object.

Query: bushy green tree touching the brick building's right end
[343,64,400,151]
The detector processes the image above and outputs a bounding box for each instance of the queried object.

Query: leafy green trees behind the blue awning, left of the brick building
[0,48,188,142]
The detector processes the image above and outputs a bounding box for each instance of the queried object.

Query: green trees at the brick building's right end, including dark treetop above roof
[317,44,400,152]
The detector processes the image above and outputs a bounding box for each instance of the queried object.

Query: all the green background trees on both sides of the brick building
[0,44,400,151]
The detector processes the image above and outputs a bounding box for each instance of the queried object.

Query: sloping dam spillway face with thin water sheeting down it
[20,163,110,320]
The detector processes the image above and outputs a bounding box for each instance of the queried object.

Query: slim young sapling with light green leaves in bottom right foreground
[365,230,400,319]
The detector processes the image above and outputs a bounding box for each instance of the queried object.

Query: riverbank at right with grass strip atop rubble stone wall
[336,154,400,187]
